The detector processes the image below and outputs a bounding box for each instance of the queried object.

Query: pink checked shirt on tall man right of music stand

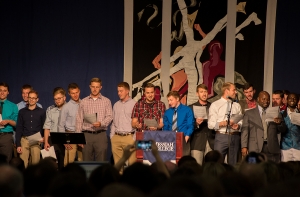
[75,94,112,132]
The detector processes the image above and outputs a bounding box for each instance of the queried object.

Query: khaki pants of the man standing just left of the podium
[111,134,136,169]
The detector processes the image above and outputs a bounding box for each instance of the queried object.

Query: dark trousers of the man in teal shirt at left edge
[0,133,13,163]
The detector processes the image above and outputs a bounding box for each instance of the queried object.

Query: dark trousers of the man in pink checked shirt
[82,132,108,161]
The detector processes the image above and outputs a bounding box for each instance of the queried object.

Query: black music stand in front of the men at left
[50,132,86,164]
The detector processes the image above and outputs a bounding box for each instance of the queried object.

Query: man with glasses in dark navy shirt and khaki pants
[16,90,46,168]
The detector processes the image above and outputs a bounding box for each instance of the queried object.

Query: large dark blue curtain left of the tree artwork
[0,0,124,108]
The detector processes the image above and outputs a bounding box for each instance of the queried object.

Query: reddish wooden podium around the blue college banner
[136,131,184,163]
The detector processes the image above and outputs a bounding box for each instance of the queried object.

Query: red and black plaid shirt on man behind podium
[131,100,166,130]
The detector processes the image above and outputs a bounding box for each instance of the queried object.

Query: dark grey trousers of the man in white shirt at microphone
[214,133,241,166]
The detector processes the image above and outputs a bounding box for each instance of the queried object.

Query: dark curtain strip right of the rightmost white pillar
[273,0,300,93]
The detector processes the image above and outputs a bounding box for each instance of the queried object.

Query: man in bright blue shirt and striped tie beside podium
[163,91,194,156]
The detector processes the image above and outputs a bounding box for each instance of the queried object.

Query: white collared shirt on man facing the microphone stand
[208,97,242,133]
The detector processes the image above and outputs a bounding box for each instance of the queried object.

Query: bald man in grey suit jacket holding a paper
[241,91,287,163]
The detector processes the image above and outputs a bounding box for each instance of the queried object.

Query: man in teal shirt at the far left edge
[0,82,18,162]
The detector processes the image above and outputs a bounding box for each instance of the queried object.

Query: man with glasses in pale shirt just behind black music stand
[44,87,66,169]
